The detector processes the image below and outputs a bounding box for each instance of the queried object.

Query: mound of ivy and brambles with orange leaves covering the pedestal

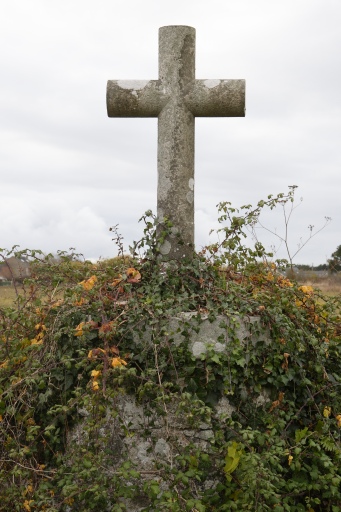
[0,193,341,512]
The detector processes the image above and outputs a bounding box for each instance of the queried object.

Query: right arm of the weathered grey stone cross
[184,80,245,117]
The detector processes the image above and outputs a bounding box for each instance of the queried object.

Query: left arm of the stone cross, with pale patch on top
[107,80,169,117]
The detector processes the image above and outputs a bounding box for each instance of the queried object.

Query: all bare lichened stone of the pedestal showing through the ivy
[68,313,270,512]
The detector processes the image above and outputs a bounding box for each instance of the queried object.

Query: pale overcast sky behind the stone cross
[0,0,341,265]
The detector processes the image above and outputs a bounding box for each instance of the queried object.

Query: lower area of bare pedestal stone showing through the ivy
[68,392,220,512]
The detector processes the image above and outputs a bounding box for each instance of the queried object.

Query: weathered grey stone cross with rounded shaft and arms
[107,26,245,260]
